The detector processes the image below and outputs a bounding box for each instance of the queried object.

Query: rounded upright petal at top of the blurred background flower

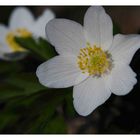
[9,7,34,30]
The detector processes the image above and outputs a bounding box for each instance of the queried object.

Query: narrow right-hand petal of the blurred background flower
[33,9,55,38]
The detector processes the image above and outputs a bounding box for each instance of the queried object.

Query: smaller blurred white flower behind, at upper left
[0,7,55,60]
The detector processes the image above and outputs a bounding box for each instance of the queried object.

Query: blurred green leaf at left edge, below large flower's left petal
[0,73,47,100]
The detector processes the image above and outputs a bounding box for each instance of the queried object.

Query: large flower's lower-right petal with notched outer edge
[109,62,137,95]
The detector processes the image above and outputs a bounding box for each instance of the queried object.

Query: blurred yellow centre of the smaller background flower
[6,28,32,52]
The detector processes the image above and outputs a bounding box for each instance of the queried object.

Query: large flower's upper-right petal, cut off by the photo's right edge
[109,34,140,64]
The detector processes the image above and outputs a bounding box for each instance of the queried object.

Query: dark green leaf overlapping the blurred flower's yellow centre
[15,37,56,60]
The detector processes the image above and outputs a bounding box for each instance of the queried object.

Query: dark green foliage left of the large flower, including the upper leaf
[0,38,72,134]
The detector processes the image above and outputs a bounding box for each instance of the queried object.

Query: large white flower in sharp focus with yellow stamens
[36,7,140,116]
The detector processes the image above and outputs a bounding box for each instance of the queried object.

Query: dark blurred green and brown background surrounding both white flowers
[0,6,140,134]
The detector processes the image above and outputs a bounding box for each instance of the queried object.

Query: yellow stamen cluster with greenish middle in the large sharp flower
[77,43,112,76]
